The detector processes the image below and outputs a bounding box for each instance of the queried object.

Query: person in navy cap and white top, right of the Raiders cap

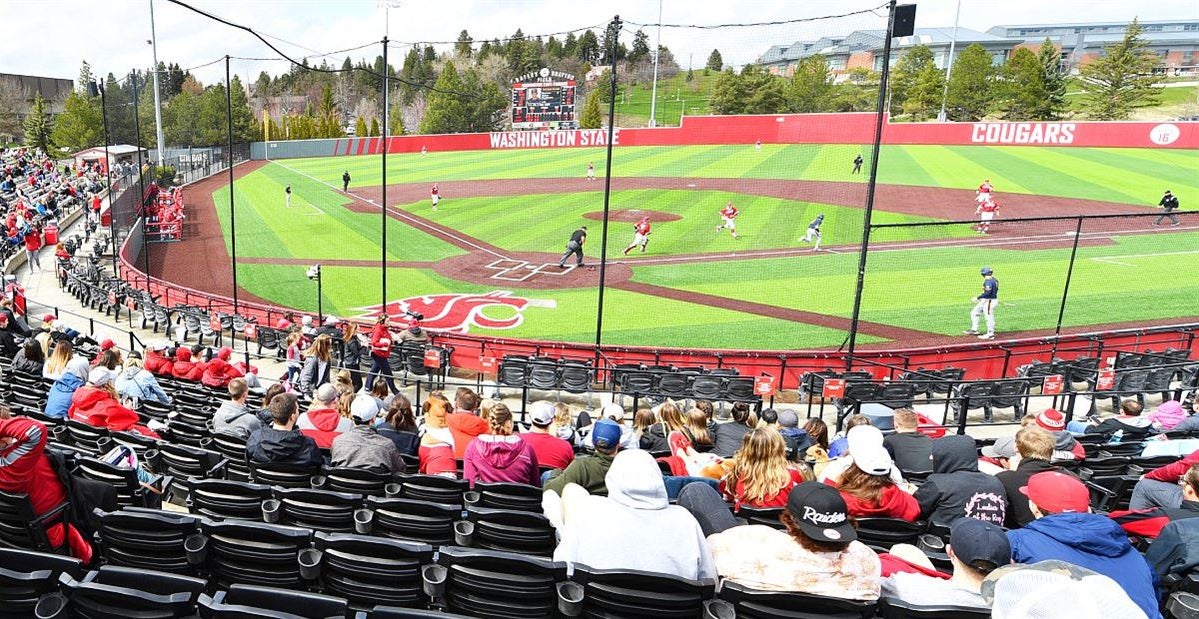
[882,518,1012,608]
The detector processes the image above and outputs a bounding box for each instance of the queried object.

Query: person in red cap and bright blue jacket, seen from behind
[1007,471,1161,618]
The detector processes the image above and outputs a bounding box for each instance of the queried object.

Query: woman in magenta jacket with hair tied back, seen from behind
[462,404,541,486]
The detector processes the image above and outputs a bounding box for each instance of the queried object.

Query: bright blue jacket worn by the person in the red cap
[1007,513,1162,619]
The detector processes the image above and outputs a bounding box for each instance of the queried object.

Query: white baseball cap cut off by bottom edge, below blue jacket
[981,560,1145,619]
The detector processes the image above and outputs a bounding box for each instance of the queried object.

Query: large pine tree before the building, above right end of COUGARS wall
[1080,19,1164,120]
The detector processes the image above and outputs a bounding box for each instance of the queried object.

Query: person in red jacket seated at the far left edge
[0,405,92,565]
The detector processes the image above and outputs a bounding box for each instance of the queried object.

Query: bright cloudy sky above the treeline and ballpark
[0,0,1199,84]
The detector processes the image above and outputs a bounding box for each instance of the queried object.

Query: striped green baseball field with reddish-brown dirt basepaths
[152,144,1199,349]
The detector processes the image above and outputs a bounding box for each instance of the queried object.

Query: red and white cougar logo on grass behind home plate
[359,290,556,333]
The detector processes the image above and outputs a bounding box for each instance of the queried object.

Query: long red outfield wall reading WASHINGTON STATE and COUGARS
[251,113,1199,160]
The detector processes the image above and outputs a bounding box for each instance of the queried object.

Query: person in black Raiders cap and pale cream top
[707,481,882,600]
